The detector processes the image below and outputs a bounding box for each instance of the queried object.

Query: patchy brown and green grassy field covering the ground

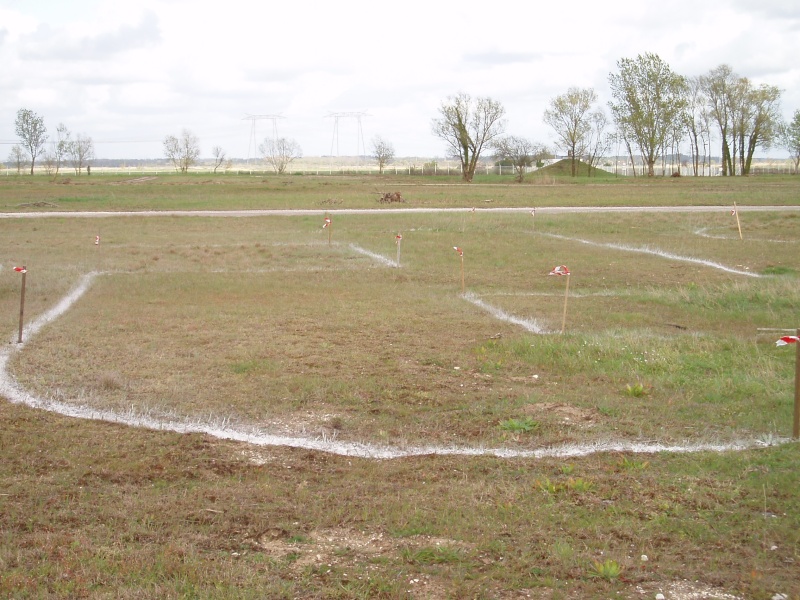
[0,176,800,600]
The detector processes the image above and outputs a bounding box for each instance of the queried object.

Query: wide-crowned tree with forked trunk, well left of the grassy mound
[432,92,506,182]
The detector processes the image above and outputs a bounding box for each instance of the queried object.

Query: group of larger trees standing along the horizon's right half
[432,53,800,181]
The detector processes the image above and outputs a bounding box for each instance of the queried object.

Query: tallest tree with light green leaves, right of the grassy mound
[609,53,686,177]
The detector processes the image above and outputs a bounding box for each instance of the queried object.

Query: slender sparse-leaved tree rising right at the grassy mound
[544,87,597,177]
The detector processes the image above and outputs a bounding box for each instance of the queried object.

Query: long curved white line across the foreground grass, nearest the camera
[0,273,791,459]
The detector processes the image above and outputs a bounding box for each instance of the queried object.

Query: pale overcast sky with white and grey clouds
[0,0,800,159]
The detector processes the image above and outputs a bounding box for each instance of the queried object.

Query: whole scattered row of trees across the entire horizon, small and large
[9,53,800,182]
